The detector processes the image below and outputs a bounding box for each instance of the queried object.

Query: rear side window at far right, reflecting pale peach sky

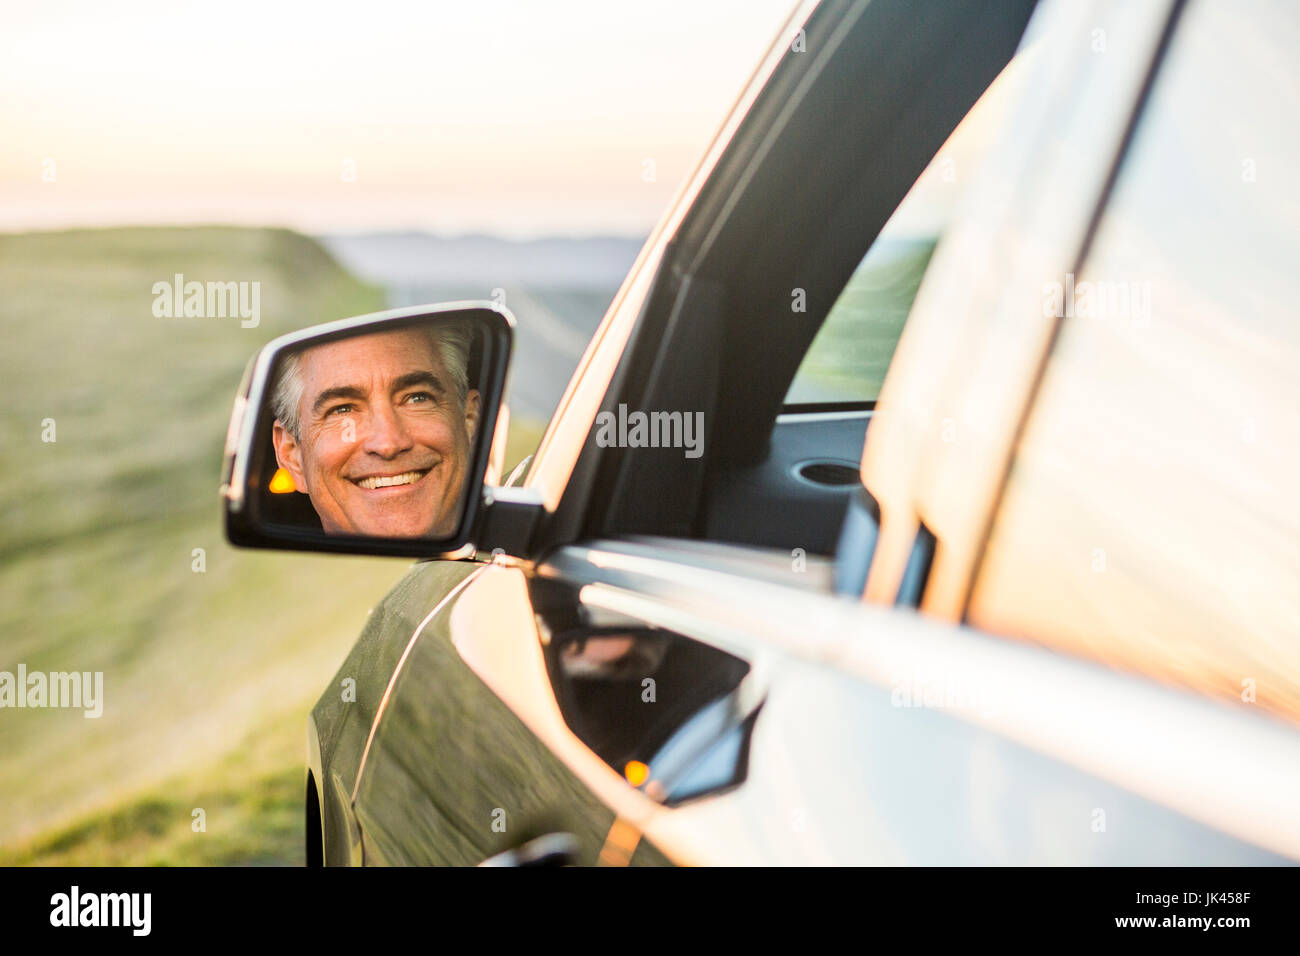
[967,3,1300,718]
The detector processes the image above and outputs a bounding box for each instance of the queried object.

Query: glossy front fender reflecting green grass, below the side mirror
[355,566,614,865]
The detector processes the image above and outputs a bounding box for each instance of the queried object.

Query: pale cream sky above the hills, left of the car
[0,0,794,237]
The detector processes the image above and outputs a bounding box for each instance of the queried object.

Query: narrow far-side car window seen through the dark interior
[785,41,1028,406]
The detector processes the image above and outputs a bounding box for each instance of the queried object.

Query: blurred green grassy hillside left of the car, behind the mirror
[0,228,540,865]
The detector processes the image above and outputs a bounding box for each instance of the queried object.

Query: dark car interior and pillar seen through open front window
[575,0,1034,567]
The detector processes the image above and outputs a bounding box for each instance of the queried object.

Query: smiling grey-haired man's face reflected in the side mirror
[274,329,478,537]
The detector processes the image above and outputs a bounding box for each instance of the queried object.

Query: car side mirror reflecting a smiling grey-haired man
[221,302,515,557]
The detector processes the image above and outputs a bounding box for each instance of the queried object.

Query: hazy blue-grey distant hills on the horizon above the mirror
[317,232,644,289]
